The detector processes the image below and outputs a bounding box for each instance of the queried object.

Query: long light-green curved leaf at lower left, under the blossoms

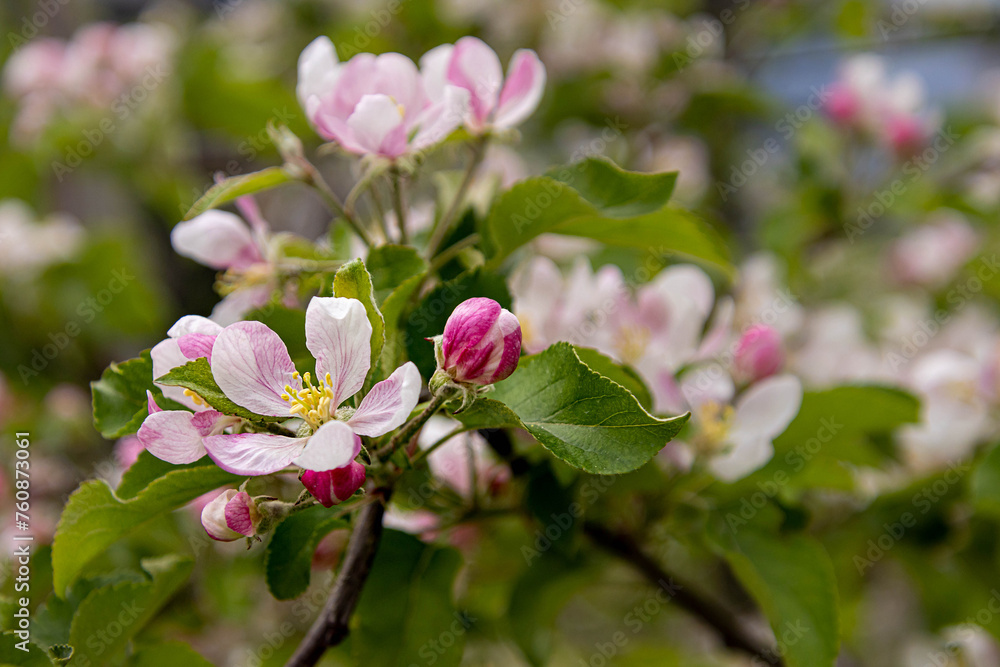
[52,465,242,595]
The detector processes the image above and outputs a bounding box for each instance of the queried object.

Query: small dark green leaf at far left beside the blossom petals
[90,350,180,440]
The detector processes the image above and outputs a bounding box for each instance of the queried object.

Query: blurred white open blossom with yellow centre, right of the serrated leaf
[681,367,802,482]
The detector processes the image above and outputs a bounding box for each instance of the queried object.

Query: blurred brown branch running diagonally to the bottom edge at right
[583,521,784,667]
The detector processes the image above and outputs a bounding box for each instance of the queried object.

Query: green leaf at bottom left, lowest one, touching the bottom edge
[69,556,194,665]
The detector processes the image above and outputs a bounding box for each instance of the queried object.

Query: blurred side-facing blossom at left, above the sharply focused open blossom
[170,197,278,325]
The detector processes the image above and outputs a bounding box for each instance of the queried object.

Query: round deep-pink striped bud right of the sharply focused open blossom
[439,297,521,384]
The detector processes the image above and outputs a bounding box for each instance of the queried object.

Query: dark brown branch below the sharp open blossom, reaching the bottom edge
[285,498,388,667]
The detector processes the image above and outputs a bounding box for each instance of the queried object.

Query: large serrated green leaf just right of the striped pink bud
[493,343,689,475]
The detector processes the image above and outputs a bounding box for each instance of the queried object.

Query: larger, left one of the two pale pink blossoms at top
[296,37,469,159]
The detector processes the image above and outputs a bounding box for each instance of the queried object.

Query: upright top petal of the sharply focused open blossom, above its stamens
[304,297,372,408]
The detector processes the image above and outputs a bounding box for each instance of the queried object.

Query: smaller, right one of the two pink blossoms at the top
[420,37,545,133]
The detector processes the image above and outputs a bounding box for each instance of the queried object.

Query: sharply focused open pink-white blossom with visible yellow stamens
[193,297,421,475]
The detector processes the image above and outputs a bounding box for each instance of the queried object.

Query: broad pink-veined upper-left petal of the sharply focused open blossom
[212,322,298,417]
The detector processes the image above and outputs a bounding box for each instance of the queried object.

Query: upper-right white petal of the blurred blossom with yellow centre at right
[729,375,802,440]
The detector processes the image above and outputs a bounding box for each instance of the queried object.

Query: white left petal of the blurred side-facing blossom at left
[170,211,264,269]
